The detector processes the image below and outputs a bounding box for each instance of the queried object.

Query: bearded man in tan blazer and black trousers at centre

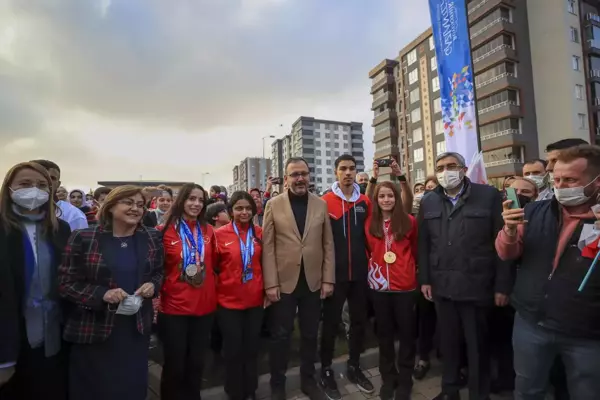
[262,158,335,400]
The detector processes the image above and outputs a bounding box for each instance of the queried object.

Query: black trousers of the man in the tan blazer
[268,284,321,388]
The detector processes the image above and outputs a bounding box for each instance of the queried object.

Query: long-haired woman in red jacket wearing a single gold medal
[365,182,417,400]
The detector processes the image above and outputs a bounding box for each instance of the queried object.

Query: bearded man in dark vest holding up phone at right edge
[496,145,600,400]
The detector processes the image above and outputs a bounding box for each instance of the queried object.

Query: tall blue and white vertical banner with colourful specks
[429,0,482,168]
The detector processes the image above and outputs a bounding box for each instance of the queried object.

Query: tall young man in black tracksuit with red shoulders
[319,154,375,400]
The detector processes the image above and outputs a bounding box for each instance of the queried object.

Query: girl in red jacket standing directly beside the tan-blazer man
[216,191,264,400]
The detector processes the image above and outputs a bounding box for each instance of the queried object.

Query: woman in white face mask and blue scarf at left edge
[0,163,71,400]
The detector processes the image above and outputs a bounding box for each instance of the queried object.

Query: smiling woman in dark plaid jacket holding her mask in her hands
[59,186,164,400]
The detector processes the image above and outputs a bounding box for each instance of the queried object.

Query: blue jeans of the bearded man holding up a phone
[513,313,600,400]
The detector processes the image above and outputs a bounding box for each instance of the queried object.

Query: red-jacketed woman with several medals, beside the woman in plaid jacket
[158,183,217,400]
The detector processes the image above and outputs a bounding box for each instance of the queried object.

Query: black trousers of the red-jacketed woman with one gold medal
[371,290,417,396]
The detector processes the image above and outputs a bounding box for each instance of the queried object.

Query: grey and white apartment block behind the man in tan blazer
[271,117,365,192]
